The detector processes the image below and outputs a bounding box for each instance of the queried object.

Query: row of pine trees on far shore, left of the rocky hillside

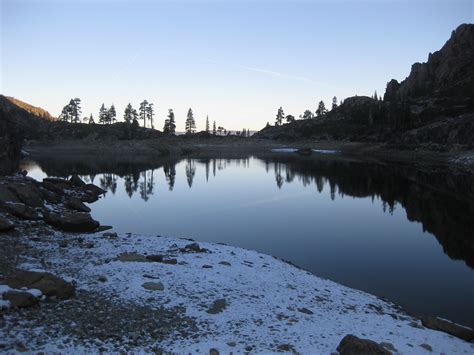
[59,98,250,137]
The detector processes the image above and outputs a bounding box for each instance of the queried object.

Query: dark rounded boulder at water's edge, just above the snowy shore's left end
[44,211,99,232]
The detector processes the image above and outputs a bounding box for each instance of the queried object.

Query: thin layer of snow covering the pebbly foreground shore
[12,233,474,354]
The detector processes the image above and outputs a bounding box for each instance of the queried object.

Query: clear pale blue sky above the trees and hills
[0,0,474,130]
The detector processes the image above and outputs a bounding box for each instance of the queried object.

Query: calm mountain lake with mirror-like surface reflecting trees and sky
[23,153,474,326]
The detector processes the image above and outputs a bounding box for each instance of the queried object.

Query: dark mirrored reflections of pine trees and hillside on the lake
[25,156,474,268]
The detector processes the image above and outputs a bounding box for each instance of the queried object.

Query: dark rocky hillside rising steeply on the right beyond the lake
[256,24,474,148]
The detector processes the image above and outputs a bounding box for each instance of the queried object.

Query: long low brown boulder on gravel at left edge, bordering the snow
[1,270,75,300]
